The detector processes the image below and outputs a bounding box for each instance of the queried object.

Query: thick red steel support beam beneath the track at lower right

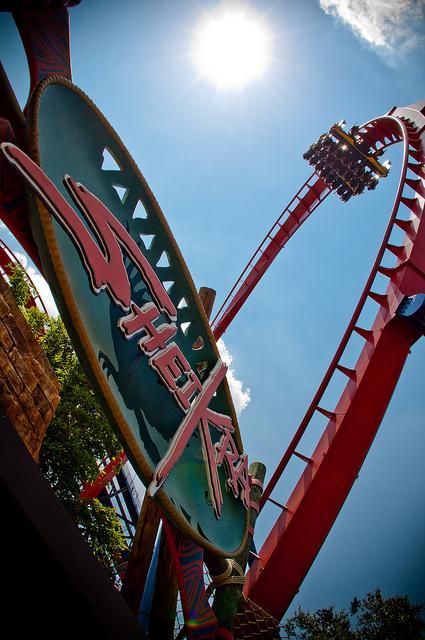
[246,318,419,620]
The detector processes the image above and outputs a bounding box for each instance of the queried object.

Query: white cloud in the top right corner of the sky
[320,0,425,54]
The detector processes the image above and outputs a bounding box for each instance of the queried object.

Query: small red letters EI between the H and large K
[149,342,202,411]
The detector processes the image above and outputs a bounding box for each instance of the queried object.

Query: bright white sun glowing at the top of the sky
[192,5,271,89]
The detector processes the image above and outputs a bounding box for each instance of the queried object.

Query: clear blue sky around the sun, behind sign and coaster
[0,0,425,620]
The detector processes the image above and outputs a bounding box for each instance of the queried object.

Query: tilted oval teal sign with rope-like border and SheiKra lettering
[16,78,250,556]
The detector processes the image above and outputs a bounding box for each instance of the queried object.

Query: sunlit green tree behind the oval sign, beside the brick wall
[9,265,127,569]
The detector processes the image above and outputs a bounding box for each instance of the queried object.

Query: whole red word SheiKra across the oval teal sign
[1,142,250,518]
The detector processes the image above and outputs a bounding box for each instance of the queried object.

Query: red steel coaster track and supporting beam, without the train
[213,102,425,619]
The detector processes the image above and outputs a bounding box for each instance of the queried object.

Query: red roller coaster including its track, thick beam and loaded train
[0,2,425,637]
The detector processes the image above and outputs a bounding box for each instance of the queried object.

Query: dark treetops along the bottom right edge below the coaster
[282,589,425,640]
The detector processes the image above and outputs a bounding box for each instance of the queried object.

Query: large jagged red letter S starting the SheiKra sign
[1,142,177,320]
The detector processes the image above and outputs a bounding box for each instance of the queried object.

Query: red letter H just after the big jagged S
[118,302,177,355]
